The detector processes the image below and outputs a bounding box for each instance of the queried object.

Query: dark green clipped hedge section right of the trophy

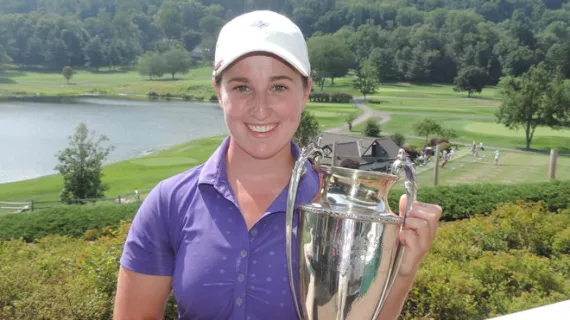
[388,179,570,221]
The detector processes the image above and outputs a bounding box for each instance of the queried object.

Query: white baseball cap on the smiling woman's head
[213,10,311,77]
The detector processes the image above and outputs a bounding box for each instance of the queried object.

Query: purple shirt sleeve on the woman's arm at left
[120,183,175,276]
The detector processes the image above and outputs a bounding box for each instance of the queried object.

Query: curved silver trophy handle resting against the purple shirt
[285,137,324,319]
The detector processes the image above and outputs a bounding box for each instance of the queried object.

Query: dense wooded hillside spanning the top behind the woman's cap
[0,0,570,84]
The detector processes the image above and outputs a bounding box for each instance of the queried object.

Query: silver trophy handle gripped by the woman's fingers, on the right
[373,149,418,319]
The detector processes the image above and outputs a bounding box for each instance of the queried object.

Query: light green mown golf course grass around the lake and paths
[0,68,570,209]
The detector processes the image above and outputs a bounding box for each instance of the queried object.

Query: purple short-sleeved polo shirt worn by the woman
[120,137,319,320]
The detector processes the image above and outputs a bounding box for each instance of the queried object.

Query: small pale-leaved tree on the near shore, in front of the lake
[55,123,114,203]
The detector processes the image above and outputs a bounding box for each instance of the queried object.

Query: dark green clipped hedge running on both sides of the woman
[0,181,570,242]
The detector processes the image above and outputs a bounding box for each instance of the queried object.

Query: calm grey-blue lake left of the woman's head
[0,98,227,183]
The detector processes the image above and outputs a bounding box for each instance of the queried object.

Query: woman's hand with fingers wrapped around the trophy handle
[398,195,442,277]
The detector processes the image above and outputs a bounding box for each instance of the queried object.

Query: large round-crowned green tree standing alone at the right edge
[496,62,570,149]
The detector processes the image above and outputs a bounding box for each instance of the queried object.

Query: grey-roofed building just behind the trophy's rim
[321,132,400,172]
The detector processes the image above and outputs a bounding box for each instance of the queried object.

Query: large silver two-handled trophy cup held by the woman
[285,138,417,320]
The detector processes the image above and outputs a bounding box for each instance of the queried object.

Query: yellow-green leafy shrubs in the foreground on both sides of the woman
[0,204,570,320]
